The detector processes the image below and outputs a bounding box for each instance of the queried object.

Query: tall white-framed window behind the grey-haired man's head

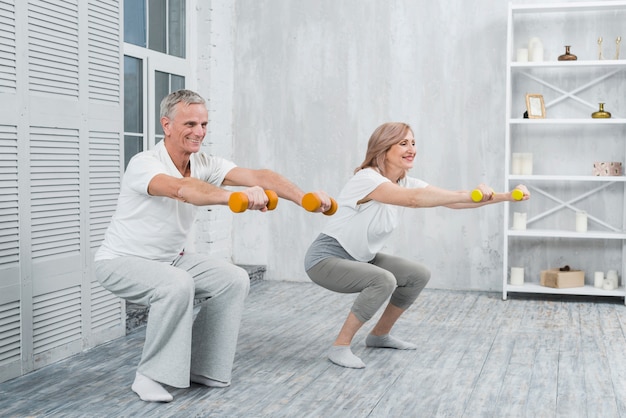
[124,0,191,168]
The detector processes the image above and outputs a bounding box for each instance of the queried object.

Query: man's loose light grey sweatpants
[95,253,250,388]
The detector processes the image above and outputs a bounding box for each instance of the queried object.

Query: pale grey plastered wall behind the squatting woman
[213,0,616,290]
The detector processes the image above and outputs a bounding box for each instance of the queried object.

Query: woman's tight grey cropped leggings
[307,253,430,322]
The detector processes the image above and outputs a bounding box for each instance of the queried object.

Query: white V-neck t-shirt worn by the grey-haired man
[95,141,236,262]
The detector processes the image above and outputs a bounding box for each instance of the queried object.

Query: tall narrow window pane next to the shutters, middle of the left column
[124,56,143,133]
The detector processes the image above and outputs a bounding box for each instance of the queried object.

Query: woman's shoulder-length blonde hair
[354,122,413,180]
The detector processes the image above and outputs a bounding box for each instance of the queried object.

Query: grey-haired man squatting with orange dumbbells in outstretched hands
[95,90,331,402]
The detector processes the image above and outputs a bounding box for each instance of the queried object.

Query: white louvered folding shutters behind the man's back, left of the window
[0,0,125,381]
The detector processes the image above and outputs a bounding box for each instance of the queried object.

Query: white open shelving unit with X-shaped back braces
[502,1,626,303]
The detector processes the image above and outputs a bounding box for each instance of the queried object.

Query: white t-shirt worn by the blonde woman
[322,168,428,262]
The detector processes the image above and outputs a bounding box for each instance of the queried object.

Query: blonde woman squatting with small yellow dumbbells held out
[305,122,530,368]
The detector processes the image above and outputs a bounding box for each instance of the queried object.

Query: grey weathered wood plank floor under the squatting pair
[0,281,626,418]
